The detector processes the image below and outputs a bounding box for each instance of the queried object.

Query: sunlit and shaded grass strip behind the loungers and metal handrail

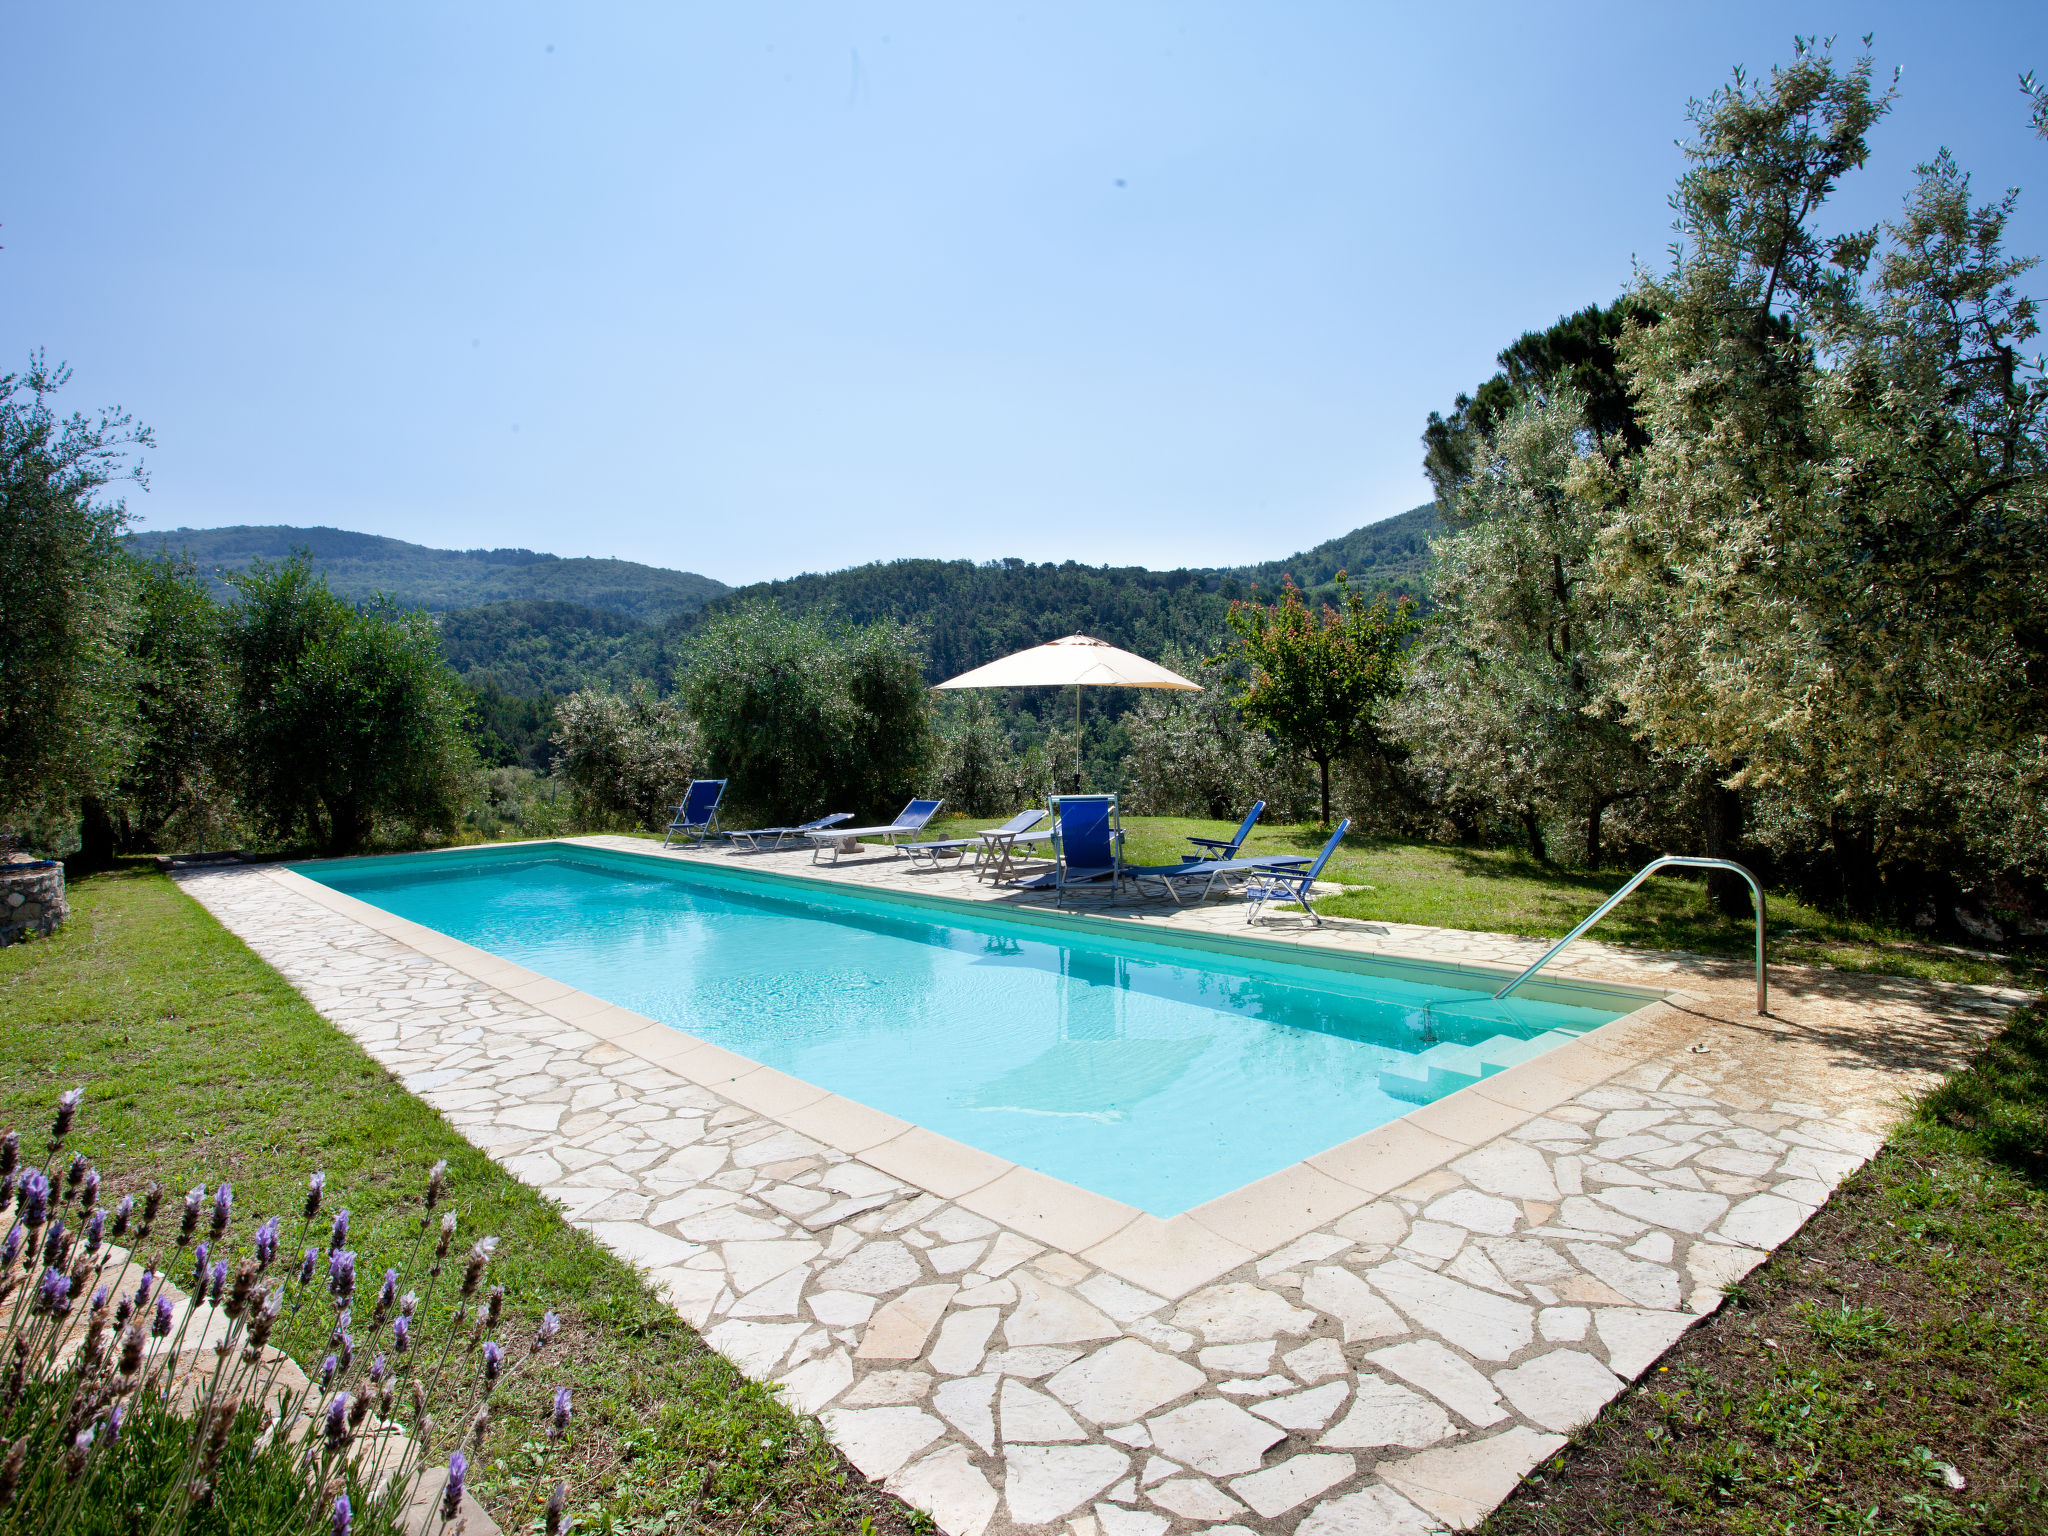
[917,817,2044,987]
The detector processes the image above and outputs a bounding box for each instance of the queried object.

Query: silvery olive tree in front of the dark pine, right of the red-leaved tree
[1393,391,1657,868]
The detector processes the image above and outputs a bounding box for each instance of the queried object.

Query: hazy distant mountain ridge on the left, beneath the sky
[127,526,729,623]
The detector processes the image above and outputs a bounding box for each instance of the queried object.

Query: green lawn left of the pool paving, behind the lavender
[0,866,926,1536]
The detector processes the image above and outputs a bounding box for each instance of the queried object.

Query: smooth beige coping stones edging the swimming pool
[270,838,1706,1300]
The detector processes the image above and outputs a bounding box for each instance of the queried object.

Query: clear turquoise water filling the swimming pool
[299,846,1616,1217]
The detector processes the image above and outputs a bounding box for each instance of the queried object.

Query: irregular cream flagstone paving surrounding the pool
[182,840,2017,1536]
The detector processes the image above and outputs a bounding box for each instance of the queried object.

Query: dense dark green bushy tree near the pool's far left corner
[225,555,477,854]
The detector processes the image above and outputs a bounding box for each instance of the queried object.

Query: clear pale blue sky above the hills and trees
[0,0,2048,582]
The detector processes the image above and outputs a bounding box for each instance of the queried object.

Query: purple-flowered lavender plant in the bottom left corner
[0,1090,571,1536]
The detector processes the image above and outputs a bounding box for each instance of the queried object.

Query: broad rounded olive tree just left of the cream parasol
[678,602,938,821]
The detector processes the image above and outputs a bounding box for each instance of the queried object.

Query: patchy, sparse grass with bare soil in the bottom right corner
[1481,1006,2048,1536]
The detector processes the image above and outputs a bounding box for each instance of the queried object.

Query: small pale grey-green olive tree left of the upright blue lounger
[553,684,705,827]
